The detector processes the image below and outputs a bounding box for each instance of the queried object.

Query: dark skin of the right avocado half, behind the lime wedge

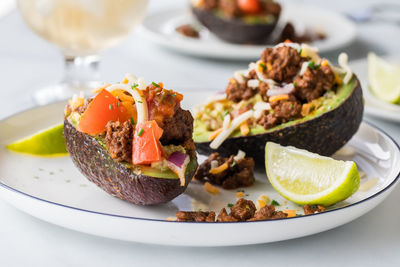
[196,78,364,164]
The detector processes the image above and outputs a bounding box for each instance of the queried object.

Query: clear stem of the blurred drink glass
[62,55,100,91]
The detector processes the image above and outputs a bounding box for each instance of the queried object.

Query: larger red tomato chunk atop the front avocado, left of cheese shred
[78,89,130,135]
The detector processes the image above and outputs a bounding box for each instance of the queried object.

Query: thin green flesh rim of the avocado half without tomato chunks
[193,78,357,142]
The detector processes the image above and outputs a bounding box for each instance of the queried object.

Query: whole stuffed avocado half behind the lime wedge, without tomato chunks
[193,43,363,162]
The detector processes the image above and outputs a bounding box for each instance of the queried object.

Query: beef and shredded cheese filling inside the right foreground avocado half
[194,42,352,149]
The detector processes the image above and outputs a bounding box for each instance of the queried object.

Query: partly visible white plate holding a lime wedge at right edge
[350,55,400,122]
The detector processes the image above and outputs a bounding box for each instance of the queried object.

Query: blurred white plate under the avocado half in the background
[142,4,356,60]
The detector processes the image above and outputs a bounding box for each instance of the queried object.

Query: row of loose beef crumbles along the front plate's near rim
[176,198,288,222]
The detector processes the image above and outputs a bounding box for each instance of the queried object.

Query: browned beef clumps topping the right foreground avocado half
[225,46,335,129]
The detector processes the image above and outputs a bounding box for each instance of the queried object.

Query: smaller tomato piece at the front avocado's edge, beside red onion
[132,120,163,164]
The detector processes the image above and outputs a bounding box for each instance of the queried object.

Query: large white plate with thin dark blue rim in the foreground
[0,96,400,246]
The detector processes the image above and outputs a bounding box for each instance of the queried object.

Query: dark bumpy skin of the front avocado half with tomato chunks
[64,120,197,205]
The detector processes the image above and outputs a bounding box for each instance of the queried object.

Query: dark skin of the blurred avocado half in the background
[191,7,278,44]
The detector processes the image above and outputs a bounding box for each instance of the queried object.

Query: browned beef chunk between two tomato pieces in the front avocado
[105,121,133,162]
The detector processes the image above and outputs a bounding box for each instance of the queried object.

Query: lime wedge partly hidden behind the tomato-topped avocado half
[6,124,68,157]
